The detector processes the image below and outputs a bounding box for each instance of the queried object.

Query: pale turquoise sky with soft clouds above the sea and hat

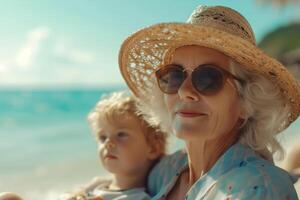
[0,0,300,89]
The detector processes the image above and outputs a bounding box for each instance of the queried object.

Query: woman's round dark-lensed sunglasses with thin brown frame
[155,64,243,95]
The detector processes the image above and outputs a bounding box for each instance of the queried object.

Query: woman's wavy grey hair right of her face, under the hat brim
[230,62,290,160]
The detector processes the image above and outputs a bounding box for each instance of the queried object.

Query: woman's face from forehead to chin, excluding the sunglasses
[164,46,241,141]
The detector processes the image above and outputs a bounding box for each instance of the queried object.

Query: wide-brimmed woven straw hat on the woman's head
[119,6,300,124]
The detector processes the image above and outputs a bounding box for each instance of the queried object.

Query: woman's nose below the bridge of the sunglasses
[178,75,199,101]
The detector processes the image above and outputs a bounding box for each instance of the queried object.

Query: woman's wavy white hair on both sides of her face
[139,62,290,161]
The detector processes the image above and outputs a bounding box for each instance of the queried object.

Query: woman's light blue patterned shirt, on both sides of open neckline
[148,143,298,200]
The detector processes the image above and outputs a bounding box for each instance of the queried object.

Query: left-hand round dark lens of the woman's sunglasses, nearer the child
[156,67,185,94]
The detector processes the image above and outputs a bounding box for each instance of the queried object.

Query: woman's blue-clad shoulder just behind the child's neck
[148,150,187,196]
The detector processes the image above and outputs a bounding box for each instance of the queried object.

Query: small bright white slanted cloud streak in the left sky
[16,27,50,69]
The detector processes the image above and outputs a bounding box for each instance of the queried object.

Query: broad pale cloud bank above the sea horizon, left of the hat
[0,27,122,87]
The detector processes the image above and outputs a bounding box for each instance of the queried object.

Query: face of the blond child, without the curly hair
[98,117,154,175]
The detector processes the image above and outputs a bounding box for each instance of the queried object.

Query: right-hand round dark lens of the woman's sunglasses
[192,67,224,95]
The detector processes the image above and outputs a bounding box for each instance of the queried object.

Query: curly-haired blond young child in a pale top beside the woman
[61,92,166,200]
